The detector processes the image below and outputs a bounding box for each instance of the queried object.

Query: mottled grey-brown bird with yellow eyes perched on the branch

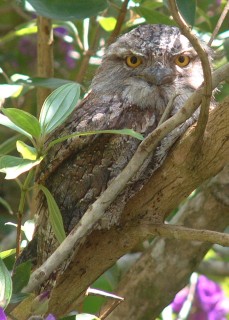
[19,24,212,282]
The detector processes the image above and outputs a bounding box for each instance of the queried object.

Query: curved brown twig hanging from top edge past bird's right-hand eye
[168,0,212,145]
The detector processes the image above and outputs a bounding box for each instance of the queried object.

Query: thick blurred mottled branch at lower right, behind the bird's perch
[107,167,229,320]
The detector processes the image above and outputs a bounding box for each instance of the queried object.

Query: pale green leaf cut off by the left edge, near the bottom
[0,259,12,308]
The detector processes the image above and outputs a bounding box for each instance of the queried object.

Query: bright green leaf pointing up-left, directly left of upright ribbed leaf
[2,108,41,138]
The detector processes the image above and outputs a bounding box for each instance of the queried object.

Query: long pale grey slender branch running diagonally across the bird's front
[23,64,229,292]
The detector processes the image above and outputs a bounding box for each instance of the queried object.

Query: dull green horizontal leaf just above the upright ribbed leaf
[15,77,78,89]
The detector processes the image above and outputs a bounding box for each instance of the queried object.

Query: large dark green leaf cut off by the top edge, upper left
[27,0,107,20]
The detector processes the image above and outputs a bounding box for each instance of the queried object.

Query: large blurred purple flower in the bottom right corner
[172,276,229,320]
